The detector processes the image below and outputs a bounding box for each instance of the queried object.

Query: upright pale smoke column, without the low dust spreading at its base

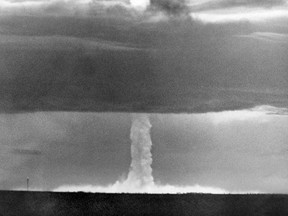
[126,114,154,188]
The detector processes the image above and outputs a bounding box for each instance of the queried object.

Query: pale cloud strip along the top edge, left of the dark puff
[0,0,137,16]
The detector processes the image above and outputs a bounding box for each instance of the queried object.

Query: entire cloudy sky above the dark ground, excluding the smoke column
[0,0,288,193]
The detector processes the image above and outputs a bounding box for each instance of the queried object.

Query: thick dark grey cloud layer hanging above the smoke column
[0,1,288,113]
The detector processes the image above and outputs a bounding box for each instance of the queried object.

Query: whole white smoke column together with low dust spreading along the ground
[55,113,233,193]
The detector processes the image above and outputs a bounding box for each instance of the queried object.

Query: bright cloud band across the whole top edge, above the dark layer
[0,0,288,23]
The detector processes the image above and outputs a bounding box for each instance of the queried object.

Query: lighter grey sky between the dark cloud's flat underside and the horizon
[0,110,288,193]
